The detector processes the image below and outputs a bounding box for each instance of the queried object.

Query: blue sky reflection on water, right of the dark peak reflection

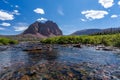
[58,47,120,66]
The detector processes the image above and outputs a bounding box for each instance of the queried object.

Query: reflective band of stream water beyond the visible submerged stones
[0,46,120,79]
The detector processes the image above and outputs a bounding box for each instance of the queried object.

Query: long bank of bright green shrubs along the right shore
[41,34,120,47]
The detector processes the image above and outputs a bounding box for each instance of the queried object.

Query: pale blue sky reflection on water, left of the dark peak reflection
[0,50,28,71]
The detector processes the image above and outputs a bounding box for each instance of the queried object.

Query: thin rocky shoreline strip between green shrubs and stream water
[0,42,120,53]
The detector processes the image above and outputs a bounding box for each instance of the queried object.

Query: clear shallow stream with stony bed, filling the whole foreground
[0,45,120,80]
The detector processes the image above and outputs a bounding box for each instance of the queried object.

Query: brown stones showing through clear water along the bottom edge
[2,61,120,80]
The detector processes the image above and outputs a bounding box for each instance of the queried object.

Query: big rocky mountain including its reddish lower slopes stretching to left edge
[0,20,63,41]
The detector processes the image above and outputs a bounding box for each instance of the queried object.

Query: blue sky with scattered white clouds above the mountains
[0,0,120,35]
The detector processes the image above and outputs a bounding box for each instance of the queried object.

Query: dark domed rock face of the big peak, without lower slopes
[23,21,62,37]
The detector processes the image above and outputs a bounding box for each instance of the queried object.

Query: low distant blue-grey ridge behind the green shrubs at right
[71,28,120,35]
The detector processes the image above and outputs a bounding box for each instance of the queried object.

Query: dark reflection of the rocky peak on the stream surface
[26,50,58,64]
